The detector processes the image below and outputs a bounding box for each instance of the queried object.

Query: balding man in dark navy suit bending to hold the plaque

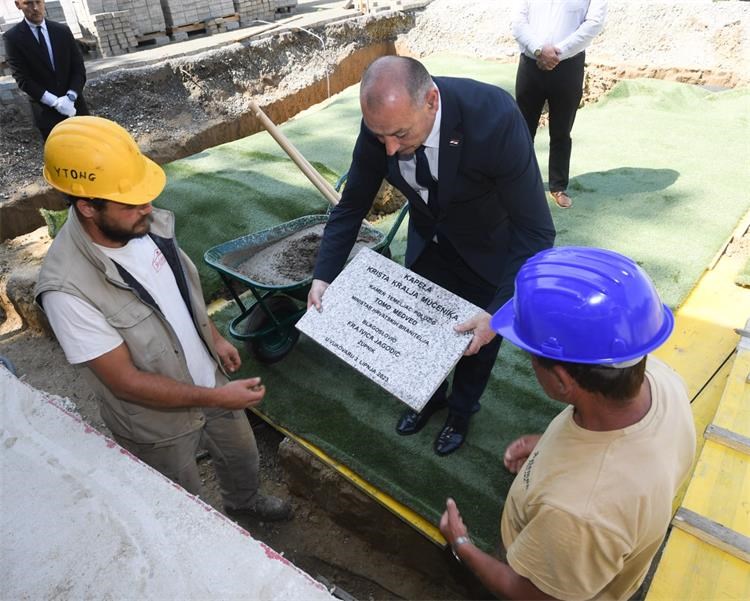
[308,56,555,455]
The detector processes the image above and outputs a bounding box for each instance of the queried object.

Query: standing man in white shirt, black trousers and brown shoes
[512,0,607,209]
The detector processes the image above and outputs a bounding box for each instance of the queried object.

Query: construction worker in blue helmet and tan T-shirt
[440,247,695,599]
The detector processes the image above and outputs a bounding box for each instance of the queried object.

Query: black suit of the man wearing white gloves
[3,20,88,131]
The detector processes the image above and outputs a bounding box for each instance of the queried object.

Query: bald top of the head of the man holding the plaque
[359,56,434,111]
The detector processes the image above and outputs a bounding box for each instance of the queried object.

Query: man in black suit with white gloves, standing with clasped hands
[3,0,89,140]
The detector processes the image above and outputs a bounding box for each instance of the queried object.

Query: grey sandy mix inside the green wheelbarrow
[233,223,381,286]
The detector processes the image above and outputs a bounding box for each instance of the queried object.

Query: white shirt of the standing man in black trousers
[512,0,607,60]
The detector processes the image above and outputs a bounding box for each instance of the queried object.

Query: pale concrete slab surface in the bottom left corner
[0,367,333,601]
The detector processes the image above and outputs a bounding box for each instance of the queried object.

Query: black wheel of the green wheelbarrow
[245,296,299,363]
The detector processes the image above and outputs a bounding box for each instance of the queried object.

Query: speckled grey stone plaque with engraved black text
[297,248,480,411]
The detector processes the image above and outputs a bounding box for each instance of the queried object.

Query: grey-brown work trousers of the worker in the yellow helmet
[114,409,259,509]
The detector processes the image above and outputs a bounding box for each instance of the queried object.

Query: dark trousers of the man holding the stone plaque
[410,242,502,418]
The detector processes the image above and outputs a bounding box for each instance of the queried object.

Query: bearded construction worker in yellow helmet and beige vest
[35,116,290,520]
